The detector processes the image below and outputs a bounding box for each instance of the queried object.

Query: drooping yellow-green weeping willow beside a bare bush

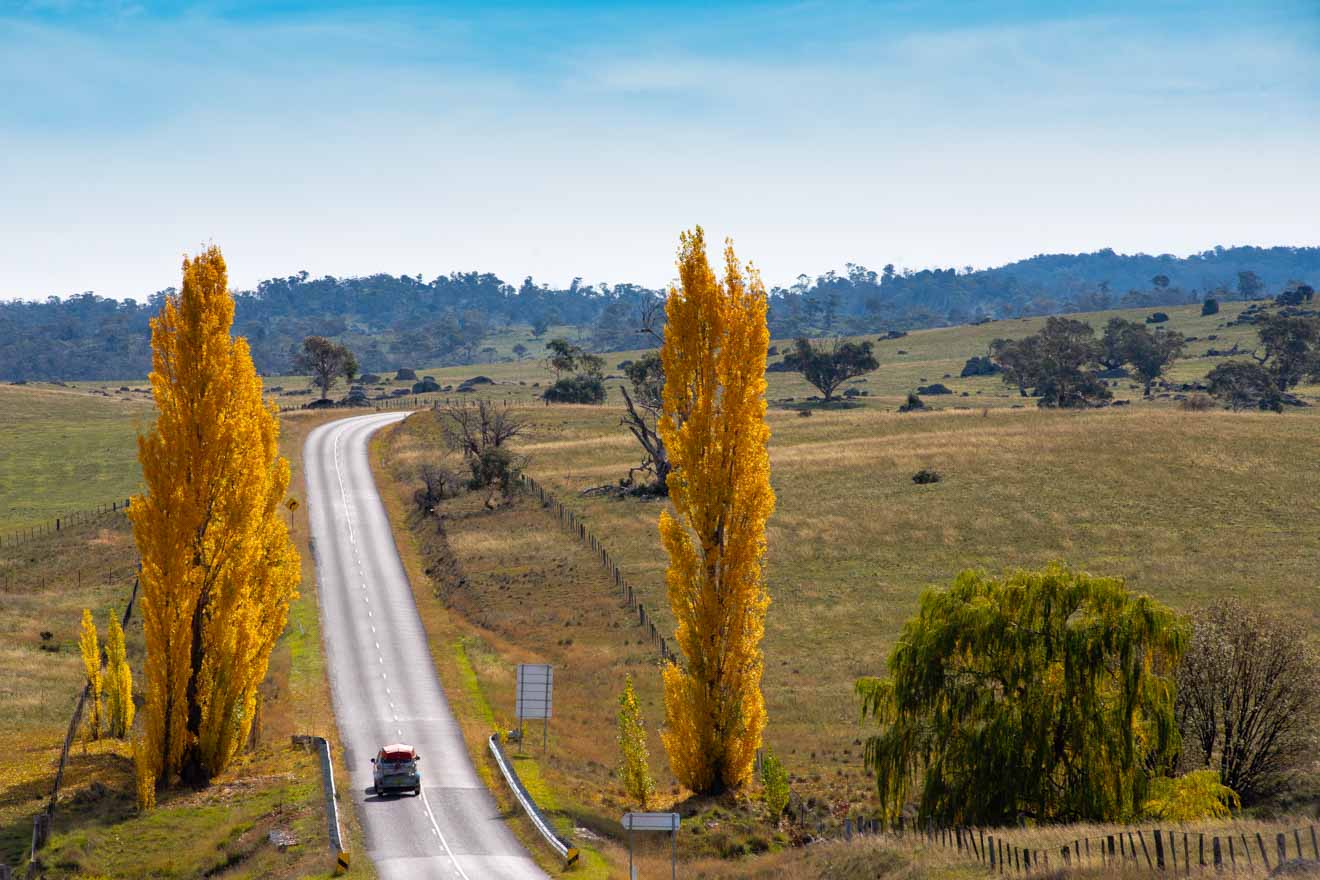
[857,566,1188,825]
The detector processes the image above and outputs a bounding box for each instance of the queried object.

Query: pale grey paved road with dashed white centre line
[304,413,546,880]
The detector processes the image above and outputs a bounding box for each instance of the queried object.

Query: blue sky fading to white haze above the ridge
[0,0,1320,298]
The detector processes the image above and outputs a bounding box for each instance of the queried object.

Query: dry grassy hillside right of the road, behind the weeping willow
[369,300,1320,876]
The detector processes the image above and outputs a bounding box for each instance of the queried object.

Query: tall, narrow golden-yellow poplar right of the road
[659,227,775,793]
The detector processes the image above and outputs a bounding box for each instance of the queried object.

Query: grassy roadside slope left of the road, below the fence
[0,401,372,877]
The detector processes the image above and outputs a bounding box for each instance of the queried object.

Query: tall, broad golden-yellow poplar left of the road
[129,245,300,806]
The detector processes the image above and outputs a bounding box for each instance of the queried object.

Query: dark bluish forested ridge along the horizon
[0,247,1320,381]
